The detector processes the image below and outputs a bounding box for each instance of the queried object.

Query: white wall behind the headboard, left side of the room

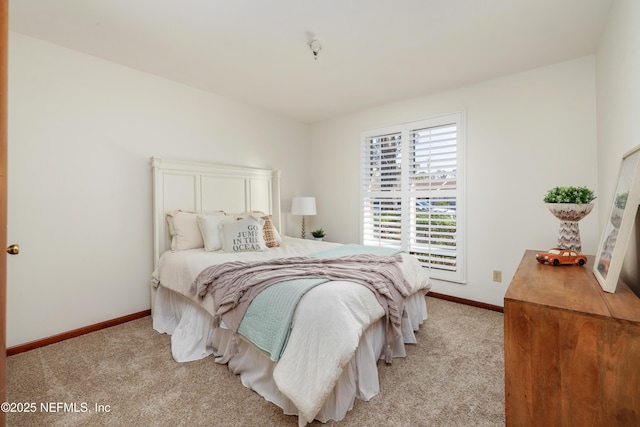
[7,33,310,347]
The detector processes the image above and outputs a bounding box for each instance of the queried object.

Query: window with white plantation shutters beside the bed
[360,113,465,283]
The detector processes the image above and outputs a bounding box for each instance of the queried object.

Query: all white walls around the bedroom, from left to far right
[7,5,640,346]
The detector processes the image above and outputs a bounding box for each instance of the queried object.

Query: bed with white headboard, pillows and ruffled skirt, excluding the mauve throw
[151,158,430,426]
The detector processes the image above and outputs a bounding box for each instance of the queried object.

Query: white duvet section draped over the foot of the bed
[273,281,384,425]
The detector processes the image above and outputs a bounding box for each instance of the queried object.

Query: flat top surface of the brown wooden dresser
[504,250,640,322]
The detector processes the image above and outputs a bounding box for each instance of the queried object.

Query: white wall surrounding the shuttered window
[311,56,599,306]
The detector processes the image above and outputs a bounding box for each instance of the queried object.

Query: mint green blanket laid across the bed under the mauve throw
[238,244,400,362]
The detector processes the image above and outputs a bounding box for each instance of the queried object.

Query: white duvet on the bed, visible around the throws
[154,237,430,425]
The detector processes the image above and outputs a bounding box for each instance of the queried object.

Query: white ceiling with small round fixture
[9,0,612,123]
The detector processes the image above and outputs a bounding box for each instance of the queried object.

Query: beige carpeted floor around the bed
[7,297,505,427]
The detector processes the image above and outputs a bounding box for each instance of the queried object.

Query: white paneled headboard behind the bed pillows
[151,157,282,269]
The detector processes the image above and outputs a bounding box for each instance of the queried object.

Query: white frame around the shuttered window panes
[359,111,467,284]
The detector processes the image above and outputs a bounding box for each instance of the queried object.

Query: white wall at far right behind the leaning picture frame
[597,0,640,294]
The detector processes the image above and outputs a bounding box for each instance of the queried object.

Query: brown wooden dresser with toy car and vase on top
[504,250,640,427]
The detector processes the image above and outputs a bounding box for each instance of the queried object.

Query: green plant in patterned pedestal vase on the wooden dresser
[543,187,596,252]
